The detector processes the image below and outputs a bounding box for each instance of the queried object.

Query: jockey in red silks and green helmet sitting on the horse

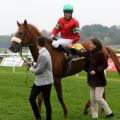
[50,4,80,57]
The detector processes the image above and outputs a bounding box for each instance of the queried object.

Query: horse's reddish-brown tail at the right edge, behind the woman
[106,46,120,74]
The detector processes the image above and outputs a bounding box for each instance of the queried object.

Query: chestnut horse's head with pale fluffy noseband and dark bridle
[9,20,35,52]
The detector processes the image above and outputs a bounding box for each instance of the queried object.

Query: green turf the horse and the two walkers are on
[0,67,120,120]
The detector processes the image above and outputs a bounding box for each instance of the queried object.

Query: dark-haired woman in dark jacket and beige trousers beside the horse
[82,39,114,119]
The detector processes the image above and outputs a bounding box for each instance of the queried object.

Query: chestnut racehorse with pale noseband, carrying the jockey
[10,20,120,116]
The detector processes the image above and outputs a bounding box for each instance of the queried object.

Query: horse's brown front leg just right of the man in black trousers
[54,78,68,118]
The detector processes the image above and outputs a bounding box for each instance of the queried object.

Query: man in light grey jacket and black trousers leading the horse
[29,38,53,120]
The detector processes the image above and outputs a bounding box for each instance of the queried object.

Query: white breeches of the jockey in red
[52,38,72,48]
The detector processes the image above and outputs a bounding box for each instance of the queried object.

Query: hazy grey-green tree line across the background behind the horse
[0,24,120,48]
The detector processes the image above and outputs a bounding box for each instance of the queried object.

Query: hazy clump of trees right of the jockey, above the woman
[81,24,120,45]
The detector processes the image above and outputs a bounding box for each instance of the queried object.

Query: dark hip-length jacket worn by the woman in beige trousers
[83,50,108,87]
